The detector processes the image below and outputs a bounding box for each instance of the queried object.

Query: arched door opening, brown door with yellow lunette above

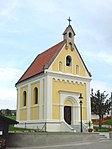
[64,100,73,125]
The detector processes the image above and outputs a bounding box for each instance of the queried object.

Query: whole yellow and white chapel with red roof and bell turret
[16,20,91,131]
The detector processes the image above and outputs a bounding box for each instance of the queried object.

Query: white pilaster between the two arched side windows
[27,83,31,121]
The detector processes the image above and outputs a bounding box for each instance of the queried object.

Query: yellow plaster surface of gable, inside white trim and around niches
[52,43,86,76]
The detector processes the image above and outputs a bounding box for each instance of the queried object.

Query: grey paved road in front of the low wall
[7,140,112,149]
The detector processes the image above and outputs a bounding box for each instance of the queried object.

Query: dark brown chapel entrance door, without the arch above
[64,106,71,125]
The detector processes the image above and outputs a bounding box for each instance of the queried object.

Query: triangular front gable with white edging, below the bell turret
[51,44,91,77]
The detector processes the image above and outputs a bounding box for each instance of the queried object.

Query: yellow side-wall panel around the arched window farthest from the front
[20,86,28,121]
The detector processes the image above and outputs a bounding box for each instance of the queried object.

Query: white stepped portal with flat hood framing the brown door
[60,91,80,126]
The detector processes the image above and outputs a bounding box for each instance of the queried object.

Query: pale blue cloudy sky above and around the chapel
[0,0,112,109]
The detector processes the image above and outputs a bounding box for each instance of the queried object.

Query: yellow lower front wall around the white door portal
[52,79,86,120]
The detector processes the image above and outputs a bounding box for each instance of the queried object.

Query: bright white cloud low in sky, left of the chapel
[0,68,22,109]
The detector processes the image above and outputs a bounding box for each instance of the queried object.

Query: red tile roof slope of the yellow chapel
[16,41,65,84]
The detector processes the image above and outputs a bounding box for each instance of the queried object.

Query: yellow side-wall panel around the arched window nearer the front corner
[30,82,40,120]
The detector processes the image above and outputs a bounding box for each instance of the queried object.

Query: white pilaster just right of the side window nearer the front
[39,79,43,120]
